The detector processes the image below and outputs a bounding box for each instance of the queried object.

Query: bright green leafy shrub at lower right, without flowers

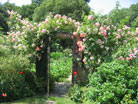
[84,60,138,104]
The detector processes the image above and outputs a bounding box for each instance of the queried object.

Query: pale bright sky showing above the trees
[0,0,138,14]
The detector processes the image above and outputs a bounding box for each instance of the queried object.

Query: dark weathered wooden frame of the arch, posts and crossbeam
[36,33,84,95]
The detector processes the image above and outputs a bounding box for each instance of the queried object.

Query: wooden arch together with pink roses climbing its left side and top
[8,11,87,94]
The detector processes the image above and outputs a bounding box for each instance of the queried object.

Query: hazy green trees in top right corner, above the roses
[108,2,138,26]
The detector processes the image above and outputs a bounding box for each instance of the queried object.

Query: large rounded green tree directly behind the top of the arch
[33,0,90,22]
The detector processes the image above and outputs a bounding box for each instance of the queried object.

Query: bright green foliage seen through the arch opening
[50,51,72,82]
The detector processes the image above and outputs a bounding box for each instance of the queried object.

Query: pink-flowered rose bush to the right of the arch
[78,14,138,72]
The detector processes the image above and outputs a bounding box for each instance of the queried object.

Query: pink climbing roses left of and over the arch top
[7,11,80,61]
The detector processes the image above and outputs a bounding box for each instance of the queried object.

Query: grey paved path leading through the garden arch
[46,75,72,104]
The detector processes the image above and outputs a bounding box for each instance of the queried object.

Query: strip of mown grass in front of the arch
[1,95,78,104]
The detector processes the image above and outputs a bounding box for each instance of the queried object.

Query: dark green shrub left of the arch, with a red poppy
[0,52,55,102]
